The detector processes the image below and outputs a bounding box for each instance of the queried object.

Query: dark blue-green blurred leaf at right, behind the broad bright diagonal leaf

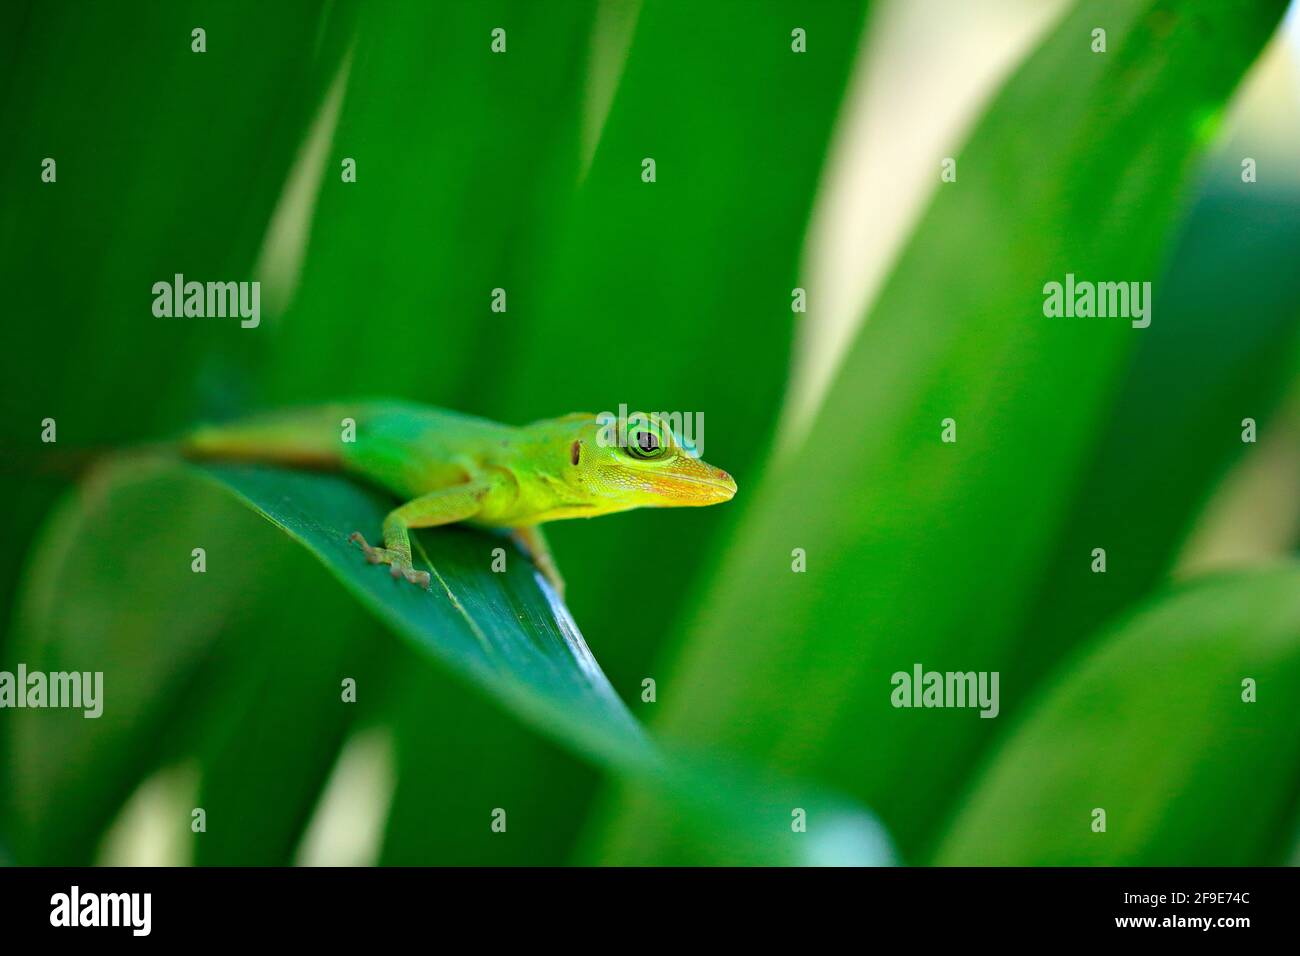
[1008,180,1300,733]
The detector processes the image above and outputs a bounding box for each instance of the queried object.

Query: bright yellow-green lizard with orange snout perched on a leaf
[181,402,736,596]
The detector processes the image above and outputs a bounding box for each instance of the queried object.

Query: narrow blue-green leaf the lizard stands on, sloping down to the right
[195,466,891,864]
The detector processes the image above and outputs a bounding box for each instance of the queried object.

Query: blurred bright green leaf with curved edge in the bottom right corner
[936,562,1300,866]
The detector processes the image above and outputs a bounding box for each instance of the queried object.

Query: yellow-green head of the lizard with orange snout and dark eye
[543,414,736,514]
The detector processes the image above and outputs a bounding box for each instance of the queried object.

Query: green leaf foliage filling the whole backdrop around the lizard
[0,0,1300,864]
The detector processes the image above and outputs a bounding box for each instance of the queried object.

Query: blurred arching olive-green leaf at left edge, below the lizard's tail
[0,463,277,865]
